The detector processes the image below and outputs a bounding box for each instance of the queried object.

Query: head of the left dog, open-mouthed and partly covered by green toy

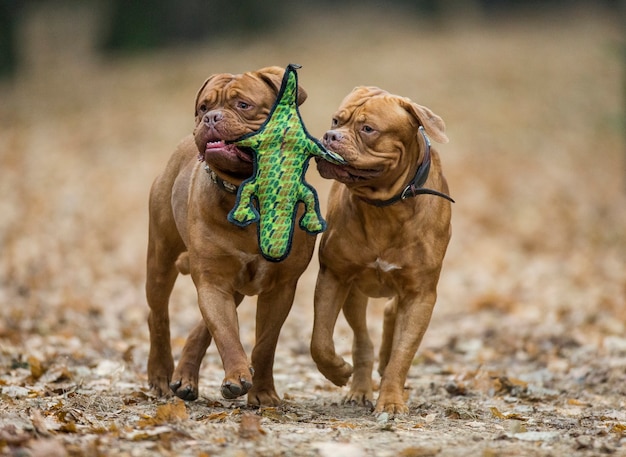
[193,67,307,180]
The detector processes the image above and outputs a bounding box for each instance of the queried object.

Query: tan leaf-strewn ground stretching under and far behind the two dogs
[0,5,626,457]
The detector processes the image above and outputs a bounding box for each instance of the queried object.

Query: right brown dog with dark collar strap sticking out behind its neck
[311,87,451,414]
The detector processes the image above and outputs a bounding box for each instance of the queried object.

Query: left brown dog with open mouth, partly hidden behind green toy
[146,67,315,405]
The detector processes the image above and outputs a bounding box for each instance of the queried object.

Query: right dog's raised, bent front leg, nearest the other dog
[311,266,352,386]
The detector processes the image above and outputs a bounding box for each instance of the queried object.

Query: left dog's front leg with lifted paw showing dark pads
[196,280,252,400]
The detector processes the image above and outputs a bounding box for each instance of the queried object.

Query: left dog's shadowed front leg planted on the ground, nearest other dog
[248,282,296,406]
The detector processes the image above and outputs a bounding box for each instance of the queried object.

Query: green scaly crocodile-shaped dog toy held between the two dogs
[228,64,346,262]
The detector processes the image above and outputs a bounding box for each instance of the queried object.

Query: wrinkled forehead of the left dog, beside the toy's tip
[200,73,272,103]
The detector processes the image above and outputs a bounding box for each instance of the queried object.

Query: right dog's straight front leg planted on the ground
[374,293,436,415]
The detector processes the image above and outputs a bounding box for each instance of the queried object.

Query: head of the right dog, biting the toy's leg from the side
[317,87,448,198]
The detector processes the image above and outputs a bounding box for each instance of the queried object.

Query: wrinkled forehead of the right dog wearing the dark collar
[335,92,413,126]
